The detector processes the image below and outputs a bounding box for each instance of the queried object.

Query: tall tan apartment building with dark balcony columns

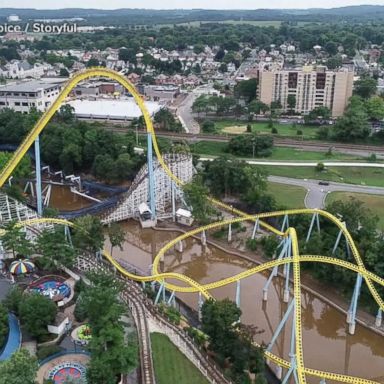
[259,66,354,117]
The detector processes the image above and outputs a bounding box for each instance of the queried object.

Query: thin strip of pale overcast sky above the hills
[0,0,383,9]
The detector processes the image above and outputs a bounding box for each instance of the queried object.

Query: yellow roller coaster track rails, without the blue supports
[0,67,384,384]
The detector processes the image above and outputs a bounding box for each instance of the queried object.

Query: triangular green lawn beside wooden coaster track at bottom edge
[151,332,208,384]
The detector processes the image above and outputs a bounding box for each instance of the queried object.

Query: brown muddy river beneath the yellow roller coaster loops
[106,221,384,383]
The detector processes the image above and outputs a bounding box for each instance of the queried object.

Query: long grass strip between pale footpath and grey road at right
[261,165,384,187]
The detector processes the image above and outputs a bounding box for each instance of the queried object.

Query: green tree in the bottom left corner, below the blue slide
[0,349,38,384]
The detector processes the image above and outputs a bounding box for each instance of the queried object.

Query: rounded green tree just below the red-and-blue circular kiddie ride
[19,294,57,339]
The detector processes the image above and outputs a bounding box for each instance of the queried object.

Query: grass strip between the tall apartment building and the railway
[215,119,318,139]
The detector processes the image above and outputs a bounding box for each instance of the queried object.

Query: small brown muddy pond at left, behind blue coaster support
[49,185,93,211]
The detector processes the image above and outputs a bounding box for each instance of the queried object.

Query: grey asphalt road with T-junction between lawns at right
[268,176,384,208]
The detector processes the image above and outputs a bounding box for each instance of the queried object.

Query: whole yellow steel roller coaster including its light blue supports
[0,68,384,384]
